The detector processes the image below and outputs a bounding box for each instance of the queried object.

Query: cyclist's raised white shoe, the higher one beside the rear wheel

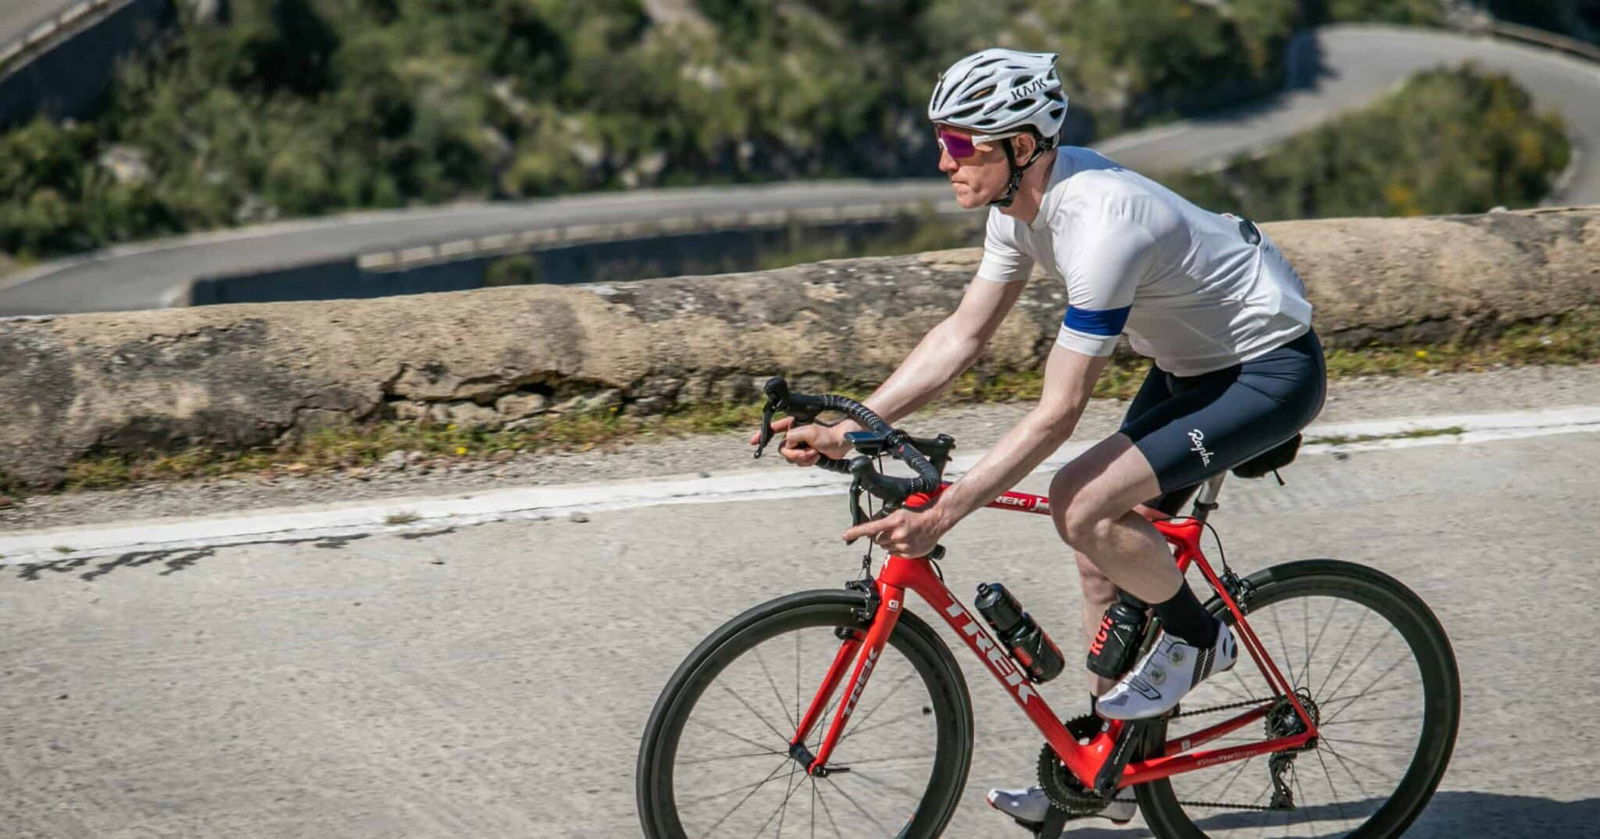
[1094,621,1238,719]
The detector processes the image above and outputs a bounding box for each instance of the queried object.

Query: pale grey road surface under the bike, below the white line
[0,434,1600,839]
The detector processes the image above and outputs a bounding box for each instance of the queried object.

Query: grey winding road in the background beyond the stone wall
[0,26,1600,315]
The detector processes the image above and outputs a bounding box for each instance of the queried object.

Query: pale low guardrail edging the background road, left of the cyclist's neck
[355,200,960,271]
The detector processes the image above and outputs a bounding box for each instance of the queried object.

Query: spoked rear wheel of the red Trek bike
[1136,559,1461,839]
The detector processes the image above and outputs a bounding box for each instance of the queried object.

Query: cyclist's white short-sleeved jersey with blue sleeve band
[978,146,1310,376]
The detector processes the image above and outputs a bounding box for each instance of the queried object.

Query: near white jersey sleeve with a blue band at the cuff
[1056,210,1155,355]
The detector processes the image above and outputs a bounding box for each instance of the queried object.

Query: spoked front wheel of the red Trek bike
[637,591,973,839]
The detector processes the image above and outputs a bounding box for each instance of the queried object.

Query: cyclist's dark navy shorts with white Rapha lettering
[1120,331,1328,514]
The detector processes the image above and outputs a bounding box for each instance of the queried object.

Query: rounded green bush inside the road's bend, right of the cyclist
[1162,64,1571,219]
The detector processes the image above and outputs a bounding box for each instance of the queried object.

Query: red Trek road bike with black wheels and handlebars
[637,379,1461,839]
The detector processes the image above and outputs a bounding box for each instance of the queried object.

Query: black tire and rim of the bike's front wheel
[635,589,973,839]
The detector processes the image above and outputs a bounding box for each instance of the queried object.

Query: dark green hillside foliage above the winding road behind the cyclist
[0,0,1574,258]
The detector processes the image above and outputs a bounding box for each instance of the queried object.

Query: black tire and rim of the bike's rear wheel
[1134,559,1461,839]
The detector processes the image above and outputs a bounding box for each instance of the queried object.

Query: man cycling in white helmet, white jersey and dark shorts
[752,50,1326,823]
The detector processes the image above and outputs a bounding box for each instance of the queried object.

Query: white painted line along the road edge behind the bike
[0,407,1600,565]
